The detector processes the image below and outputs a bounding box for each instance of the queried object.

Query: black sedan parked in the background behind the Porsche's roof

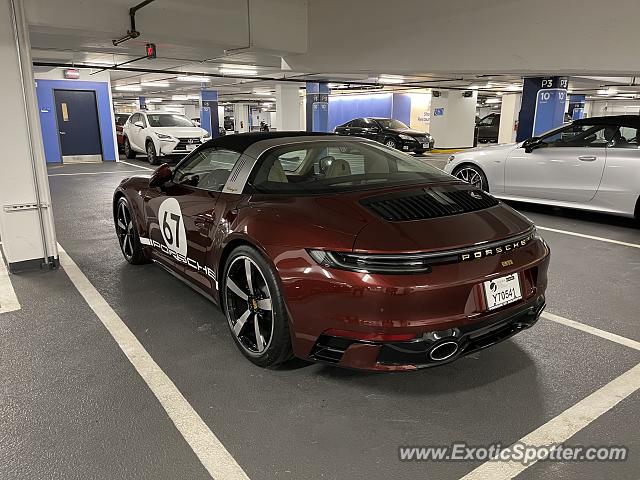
[335,117,434,153]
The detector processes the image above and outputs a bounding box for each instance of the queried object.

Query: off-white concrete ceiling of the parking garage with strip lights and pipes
[24,0,640,108]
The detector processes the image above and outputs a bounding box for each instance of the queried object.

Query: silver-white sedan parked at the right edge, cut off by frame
[444,115,640,219]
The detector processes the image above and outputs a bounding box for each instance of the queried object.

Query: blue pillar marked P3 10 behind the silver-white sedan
[516,77,569,142]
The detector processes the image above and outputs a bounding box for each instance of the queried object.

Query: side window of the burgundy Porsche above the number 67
[174,148,240,192]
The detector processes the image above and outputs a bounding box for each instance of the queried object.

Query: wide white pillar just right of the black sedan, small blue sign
[429,90,478,148]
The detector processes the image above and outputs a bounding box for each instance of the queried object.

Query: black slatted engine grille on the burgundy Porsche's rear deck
[360,188,500,222]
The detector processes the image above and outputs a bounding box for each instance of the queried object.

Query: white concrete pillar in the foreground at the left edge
[0,0,58,271]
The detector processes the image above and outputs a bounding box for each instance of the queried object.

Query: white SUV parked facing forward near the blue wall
[122,110,211,165]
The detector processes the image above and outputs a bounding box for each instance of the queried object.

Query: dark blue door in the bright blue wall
[54,90,102,162]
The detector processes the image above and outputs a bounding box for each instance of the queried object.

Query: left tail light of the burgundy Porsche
[307,250,431,275]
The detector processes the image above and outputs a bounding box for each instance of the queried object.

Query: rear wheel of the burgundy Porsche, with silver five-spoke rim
[220,245,292,367]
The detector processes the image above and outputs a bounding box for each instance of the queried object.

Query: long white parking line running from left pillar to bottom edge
[58,245,249,480]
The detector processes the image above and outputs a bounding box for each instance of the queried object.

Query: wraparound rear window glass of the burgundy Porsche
[249,140,452,194]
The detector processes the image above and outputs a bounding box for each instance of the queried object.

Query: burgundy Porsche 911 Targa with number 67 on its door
[113,132,549,370]
